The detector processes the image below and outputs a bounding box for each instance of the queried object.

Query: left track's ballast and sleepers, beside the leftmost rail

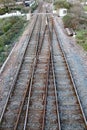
[0,11,46,130]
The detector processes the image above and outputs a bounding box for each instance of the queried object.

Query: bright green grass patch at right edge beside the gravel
[76,30,87,51]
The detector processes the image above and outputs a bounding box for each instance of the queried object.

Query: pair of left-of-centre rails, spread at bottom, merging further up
[15,17,46,130]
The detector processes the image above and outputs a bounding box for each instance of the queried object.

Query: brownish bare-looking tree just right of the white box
[63,3,83,29]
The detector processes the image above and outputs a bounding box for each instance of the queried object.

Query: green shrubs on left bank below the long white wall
[0,17,25,66]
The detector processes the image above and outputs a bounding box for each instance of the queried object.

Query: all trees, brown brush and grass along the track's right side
[54,0,87,51]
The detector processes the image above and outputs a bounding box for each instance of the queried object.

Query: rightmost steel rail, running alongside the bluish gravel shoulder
[53,20,87,128]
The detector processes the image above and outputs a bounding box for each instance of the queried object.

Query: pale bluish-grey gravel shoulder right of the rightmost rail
[54,17,87,119]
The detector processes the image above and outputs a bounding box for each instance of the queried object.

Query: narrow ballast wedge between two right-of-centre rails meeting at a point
[44,54,60,130]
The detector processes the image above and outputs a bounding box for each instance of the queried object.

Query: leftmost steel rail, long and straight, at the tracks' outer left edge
[0,17,38,123]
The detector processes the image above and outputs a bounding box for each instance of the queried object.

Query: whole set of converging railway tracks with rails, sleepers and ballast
[0,2,87,130]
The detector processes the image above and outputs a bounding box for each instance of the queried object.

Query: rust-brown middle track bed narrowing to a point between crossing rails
[14,25,50,130]
